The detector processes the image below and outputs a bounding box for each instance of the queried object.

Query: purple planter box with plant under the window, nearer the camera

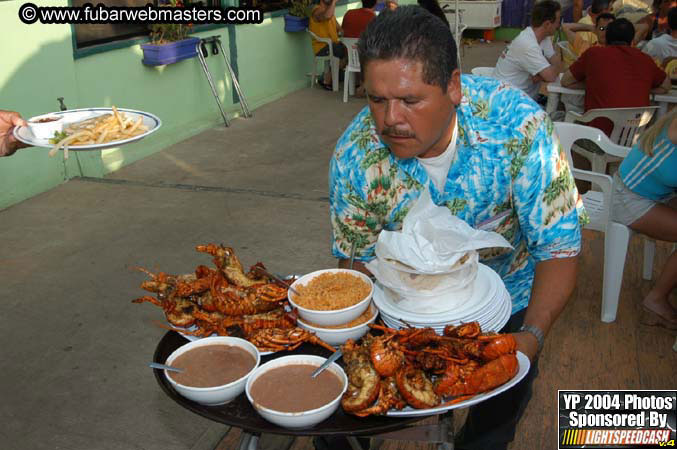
[141,0,200,66]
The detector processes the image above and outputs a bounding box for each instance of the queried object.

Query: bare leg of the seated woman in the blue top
[630,199,677,327]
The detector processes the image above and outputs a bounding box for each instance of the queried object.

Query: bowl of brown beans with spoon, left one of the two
[164,336,261,406]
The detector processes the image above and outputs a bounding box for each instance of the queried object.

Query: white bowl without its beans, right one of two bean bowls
[245,355,348,428]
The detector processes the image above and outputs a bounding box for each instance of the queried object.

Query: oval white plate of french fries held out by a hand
[14,106,162,157]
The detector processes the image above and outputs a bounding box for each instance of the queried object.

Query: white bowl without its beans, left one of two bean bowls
[165,336,261,406]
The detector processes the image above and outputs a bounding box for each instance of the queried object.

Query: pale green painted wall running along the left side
[0,0,360,209]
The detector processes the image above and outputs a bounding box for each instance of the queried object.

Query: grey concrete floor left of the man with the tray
[0,44,503,450]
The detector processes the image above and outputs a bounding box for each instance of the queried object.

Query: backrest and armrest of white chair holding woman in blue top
[554,122,630,231]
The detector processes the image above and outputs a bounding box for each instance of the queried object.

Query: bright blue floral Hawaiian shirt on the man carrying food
[329,75,587,314]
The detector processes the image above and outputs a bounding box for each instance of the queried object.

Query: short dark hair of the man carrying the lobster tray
[357,5,457,92]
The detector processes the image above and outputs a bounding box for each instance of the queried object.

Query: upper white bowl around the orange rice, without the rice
[288,269,374,325]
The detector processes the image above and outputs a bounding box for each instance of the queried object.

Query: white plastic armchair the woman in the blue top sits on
[555,122,655,322]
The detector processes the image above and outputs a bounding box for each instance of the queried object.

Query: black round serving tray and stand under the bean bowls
[153,331,453,450]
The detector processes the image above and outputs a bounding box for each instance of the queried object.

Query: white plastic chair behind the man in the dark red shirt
[564,106,658,173]
